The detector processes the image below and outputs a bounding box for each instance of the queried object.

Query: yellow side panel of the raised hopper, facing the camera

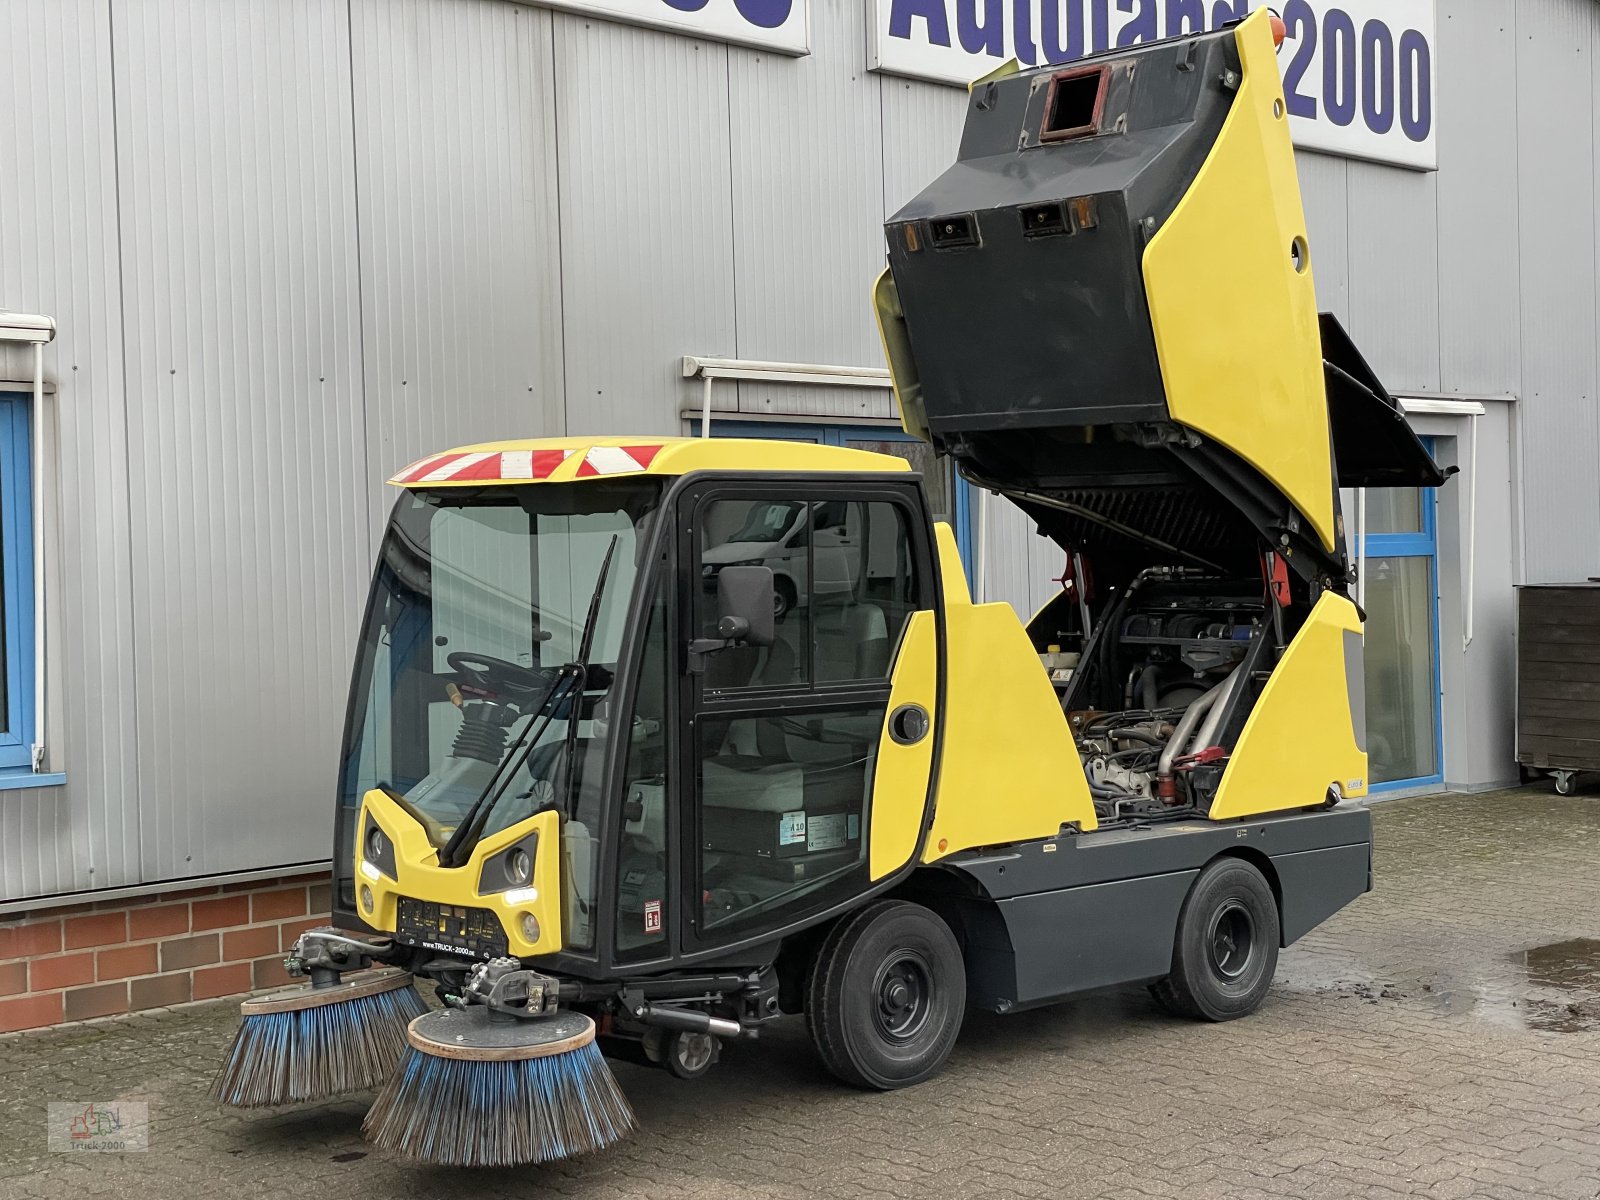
[1144,10,1336,550]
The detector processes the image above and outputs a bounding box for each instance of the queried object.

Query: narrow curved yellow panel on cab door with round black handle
[867,611,939,882]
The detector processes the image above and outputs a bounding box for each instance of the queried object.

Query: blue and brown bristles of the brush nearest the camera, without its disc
[362,1042,637,1166]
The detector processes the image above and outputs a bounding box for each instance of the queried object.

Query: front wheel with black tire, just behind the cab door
[806,901,966,1091]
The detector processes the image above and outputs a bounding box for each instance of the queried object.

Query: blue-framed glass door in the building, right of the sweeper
[1362,440,1445,795]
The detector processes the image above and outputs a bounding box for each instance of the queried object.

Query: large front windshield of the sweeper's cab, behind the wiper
[339,480,661,947]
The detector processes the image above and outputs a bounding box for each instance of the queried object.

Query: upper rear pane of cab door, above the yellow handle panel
[811,501,917,683]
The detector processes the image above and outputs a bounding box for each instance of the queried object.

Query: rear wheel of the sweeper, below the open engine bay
[1150,858,1280,1021]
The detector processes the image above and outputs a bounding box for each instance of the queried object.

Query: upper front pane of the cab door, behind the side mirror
[694,499,811,691]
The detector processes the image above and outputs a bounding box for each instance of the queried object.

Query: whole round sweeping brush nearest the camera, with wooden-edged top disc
[362,1005,637,1166]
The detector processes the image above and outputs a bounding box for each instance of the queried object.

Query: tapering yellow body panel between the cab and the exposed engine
[921,522,1099,862]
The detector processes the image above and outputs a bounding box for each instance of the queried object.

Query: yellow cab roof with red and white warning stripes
[389,435,910,488]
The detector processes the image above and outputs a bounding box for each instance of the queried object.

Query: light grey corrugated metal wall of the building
[0,0,1600,899]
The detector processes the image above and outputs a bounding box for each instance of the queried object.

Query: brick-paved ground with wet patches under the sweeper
[9,786,1600,1200]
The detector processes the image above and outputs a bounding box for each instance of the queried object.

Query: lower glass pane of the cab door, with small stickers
[699,706,885,934]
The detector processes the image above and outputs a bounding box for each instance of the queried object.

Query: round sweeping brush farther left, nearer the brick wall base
[211,968,427,1109]
